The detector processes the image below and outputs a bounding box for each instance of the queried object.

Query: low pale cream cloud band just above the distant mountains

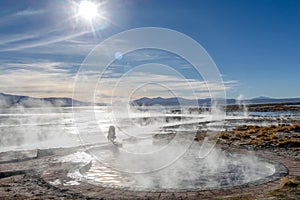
[0,54,237,102]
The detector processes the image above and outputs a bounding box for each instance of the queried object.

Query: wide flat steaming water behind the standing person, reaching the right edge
[0,107,299,152]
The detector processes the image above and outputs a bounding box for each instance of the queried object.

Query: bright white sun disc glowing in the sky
[78,1,98,20]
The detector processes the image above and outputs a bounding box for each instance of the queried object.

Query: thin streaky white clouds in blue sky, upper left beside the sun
[0,4,101,53]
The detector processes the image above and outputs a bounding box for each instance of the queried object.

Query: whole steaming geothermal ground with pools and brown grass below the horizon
[0,104,300,199]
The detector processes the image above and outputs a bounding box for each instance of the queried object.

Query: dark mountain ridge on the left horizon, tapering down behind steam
[0,93,103,108]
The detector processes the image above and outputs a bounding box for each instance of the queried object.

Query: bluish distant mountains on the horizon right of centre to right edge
[132,96,300,106]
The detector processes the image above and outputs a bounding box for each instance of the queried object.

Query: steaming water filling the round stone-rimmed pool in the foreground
[71,143,275,190]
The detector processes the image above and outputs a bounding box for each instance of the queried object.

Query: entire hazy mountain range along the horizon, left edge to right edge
[0,93,300,108]
